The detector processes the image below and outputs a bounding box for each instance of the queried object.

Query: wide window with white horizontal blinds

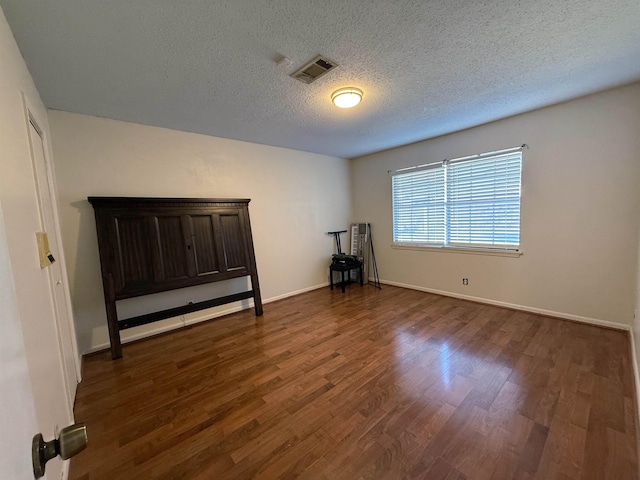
[391,147,522,250]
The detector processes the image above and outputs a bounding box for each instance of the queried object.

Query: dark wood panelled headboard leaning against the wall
[88,197,262,359]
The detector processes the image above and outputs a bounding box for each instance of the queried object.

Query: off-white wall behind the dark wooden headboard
[49,111,350,354]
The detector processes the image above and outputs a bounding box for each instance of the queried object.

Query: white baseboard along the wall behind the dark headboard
[84,282,329,355]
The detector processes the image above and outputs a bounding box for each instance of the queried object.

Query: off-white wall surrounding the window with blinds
[351,84,640,327]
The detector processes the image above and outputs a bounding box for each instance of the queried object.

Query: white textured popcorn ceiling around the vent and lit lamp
[0,0,640,157]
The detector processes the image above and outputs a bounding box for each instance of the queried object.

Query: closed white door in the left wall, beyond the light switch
[27,110,80,402]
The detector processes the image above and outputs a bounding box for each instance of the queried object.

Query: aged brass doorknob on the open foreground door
[31,423,87,478]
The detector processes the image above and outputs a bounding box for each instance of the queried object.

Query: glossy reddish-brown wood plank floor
[70,285,638,480]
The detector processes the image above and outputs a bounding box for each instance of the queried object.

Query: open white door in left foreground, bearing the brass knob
[0,205,39,479]
